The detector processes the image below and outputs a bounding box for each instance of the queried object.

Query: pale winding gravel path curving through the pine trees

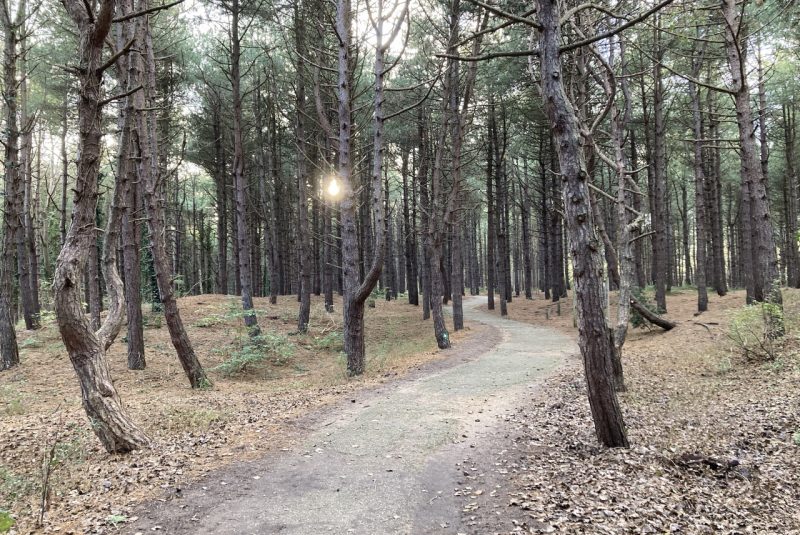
[127,298,576,535]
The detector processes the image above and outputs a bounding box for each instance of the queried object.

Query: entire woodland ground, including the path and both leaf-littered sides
[0,289,800,535]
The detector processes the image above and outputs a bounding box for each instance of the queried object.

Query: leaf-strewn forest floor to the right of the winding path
[455,289,800,534]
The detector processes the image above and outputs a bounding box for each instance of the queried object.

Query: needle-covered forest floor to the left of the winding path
[0,295,474,533]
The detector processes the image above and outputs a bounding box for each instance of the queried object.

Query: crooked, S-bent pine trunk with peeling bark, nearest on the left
[53,0,148,452]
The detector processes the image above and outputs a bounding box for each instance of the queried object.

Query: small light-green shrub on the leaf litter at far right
[728,303,783,362]
